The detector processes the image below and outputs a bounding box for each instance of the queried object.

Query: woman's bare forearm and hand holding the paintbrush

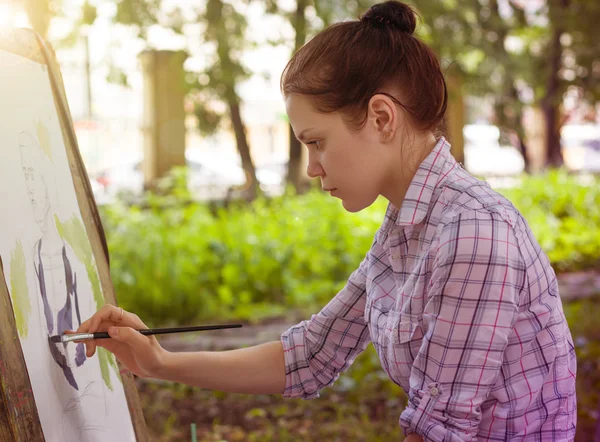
[77,304,285,394]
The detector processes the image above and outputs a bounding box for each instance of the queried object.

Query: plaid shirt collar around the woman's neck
[382,137,452,230]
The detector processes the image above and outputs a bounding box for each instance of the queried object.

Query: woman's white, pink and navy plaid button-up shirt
[281,138,576,442]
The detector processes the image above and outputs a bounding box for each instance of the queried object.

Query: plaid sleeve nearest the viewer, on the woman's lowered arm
[400,212,526,442]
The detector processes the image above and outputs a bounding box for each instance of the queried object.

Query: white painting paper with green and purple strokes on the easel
[0,50,135,442]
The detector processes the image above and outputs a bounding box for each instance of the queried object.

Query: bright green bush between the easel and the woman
[102,185,385,324]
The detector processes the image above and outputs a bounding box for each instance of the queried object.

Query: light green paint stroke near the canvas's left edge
[10,241,31,338]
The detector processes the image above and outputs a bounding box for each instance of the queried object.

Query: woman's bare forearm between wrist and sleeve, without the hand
[155,341,285,394]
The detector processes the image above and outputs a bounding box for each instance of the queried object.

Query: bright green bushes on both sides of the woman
[102,171,600,325]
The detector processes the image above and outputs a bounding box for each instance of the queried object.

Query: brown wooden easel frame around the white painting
[0,29,149,442]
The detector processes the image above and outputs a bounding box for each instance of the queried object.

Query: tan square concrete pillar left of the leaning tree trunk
[139,50,187,188]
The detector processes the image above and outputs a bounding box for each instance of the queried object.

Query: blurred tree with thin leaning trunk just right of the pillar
[115,0,260,199]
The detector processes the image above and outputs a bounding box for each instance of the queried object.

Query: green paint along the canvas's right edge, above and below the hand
[54,215,121,390]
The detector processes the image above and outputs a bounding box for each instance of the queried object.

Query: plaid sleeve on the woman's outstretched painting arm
[281,255,371,399]
